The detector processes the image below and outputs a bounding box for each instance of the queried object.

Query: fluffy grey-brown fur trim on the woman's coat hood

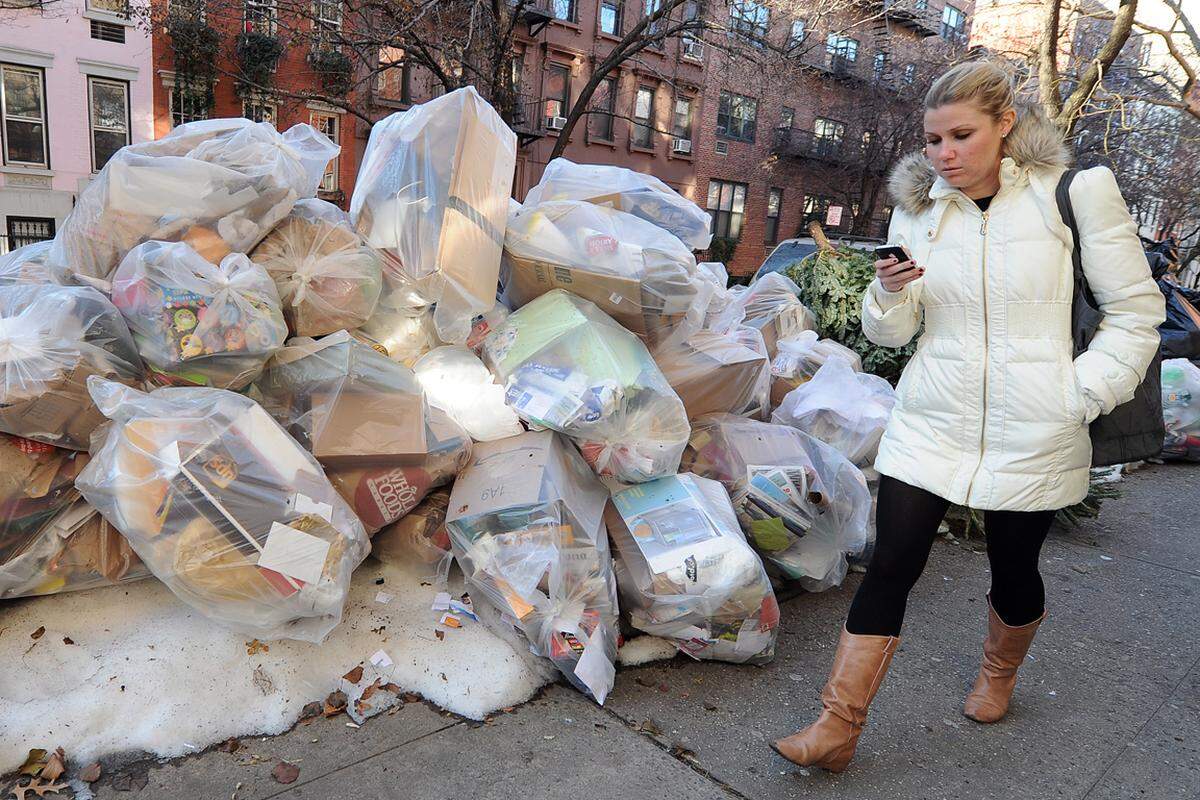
[888,104,1070,215]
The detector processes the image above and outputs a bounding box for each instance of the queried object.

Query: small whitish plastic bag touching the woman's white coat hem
[770,359,896,467]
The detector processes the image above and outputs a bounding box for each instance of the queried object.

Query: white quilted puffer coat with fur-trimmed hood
[863,109,1164,511]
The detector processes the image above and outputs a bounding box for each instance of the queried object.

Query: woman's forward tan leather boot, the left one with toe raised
[770,627,900,772]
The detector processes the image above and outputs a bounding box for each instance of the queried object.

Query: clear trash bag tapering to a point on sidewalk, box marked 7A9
[446,431,618,704]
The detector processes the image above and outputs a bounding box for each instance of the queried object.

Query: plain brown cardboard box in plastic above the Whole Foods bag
[310,391,428,467]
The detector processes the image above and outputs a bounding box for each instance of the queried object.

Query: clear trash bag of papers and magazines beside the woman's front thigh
[682,414,874,591]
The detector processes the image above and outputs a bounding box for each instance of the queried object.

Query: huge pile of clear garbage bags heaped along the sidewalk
[0,88,902,703]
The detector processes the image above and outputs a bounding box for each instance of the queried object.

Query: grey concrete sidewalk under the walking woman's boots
[56,464,1200,800]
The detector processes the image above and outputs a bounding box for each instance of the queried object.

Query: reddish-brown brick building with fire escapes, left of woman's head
[696,0,972,276]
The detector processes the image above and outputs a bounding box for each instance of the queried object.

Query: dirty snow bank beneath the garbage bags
[0,559,557,774]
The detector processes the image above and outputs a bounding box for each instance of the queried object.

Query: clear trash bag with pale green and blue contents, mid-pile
[482,289,691,483]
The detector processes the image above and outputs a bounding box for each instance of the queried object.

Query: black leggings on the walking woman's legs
[846,475,1055,636]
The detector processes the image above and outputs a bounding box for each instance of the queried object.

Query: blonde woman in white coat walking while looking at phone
[772,61,1164,771]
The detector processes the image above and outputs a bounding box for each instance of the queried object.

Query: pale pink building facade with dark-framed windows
[0,0,154,253]
